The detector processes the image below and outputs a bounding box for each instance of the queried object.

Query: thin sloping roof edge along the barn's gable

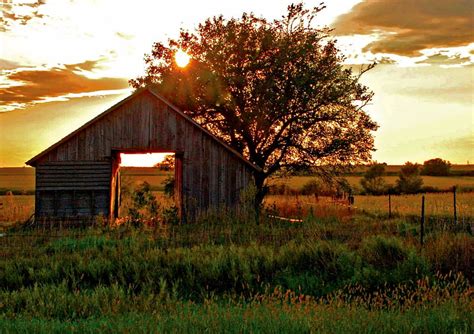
[26,88,261,171]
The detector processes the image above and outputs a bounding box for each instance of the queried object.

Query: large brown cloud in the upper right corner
[334,0,474,56]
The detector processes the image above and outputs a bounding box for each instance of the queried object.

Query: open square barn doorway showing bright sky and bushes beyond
[111,150,182,221]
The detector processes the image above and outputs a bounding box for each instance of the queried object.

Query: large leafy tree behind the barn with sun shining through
[130,4,377,204]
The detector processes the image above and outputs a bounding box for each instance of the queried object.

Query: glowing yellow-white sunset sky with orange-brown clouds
[0,0,474,167]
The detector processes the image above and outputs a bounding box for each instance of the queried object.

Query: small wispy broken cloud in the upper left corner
[0,0,46,32]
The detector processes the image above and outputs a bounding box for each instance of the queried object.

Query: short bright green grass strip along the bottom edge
[0,301,474,333]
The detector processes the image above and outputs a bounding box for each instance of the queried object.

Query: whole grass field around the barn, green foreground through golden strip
[0,169,474,333]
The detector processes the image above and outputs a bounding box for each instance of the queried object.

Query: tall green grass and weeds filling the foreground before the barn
[0,224,474,333]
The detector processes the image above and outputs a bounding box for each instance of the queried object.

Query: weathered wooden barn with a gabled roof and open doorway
[26,89,258,219]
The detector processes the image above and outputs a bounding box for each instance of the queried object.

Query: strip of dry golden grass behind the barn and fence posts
[0,192,474,226]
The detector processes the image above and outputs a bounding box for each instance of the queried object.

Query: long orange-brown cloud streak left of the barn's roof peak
[0,61,128,106]
